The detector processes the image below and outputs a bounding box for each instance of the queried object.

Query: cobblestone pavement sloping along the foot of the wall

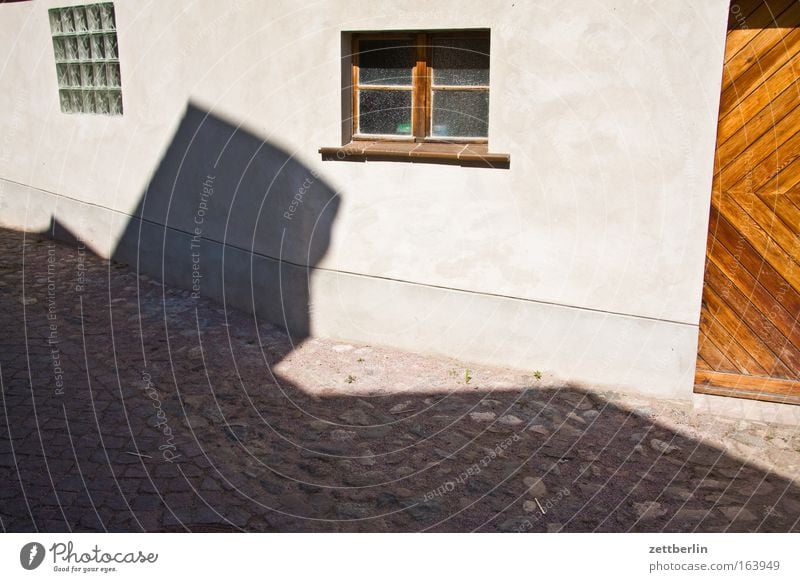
[0,231,800,532]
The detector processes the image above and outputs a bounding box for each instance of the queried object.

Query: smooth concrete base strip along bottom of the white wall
[0,180,697,400]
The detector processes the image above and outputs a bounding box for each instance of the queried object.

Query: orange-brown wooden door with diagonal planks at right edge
[695,0,800,404]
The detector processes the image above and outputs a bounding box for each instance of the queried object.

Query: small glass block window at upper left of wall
[49,2,122,115]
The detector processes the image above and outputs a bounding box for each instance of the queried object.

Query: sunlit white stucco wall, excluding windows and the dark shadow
[0,0,728,396]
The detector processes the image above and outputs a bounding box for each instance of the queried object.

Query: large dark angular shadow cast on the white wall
[108,103,339,341]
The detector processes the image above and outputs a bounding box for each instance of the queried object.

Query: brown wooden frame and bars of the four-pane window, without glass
[351,30,491,144]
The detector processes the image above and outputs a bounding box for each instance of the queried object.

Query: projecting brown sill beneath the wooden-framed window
[319,141,511,168]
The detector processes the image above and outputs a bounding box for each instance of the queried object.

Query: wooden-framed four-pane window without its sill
[353,30,489,142]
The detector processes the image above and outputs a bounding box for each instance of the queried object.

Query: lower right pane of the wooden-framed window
[431,91,489,137]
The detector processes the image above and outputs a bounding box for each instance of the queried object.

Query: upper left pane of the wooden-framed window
[358,40,416,85]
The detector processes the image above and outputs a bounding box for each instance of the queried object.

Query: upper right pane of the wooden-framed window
[431,37,489,86]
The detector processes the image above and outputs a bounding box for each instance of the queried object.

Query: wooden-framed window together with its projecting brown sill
[320,30,509,167]
